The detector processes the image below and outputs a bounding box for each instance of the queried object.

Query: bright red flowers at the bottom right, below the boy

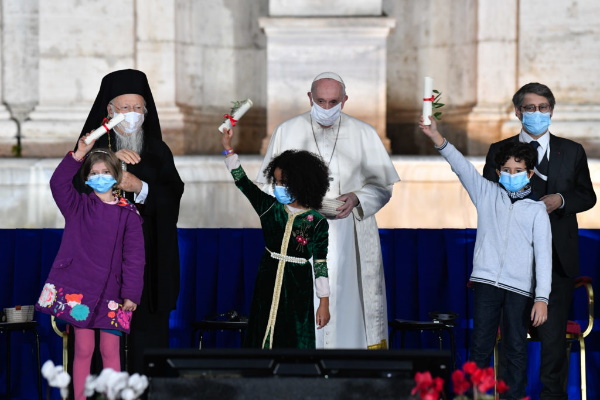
[411,361,529,400]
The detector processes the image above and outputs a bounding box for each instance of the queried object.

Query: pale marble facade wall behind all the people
[0,0,600,227]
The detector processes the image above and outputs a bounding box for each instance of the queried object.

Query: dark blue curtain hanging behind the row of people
[0,229,600,400]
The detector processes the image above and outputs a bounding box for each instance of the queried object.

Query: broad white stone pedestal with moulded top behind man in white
[260,0,396,153]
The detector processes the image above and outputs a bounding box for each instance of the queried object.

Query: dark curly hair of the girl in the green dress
[264,150,329,210]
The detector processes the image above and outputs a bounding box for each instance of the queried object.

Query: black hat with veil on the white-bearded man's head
[79,69,162,139]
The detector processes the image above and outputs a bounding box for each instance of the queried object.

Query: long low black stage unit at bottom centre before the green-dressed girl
[145,349,450,400]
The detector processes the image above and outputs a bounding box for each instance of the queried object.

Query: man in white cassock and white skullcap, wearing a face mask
[257,72,400,349]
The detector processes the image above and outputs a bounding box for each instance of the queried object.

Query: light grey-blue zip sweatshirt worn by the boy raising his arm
[439,142,552,303]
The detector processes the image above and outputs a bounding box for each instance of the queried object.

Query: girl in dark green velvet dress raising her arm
[222,129,330,349]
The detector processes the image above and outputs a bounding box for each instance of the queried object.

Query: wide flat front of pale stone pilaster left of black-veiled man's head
[22,0,135,157]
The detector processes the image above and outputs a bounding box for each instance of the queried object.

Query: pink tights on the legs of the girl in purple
[73,327,121,400]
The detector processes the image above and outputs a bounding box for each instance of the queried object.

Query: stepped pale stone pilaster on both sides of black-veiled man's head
[22,0,183,156]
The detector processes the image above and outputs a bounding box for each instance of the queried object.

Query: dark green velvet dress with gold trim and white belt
[227,156,329,349]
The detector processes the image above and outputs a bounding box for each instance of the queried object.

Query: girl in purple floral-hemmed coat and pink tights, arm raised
[36,136,145,399]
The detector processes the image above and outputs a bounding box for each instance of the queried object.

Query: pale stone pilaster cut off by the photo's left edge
[0,0,39,156]
